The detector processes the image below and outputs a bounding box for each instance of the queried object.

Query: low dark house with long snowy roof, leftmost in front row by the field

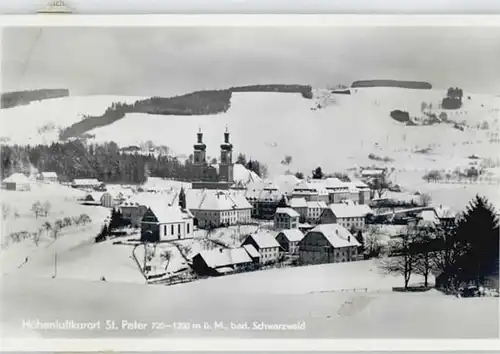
[191,247,253,276]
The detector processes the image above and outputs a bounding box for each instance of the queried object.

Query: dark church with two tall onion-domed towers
[191,127,234,189]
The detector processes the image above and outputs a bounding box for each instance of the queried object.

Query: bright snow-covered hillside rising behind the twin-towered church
[0,88,500,207]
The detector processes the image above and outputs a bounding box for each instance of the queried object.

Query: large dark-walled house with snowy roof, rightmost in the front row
[299,224,360,264]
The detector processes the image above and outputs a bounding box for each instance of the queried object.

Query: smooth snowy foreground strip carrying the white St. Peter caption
[0,276,498,338]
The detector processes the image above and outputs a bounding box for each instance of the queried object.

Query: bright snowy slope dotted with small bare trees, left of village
[0,183,110,273]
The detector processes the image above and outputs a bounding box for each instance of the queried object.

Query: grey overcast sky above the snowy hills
[2,27,500,96]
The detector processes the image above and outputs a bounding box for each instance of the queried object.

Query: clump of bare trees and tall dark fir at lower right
[380,196,499,289]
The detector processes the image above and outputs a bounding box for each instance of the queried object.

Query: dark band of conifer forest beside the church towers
[0,140,267,184]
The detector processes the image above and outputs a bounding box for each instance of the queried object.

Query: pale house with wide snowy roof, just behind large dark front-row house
[320,202,372,230]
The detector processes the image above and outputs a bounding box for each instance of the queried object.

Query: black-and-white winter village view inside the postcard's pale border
[0,16,500,342]
